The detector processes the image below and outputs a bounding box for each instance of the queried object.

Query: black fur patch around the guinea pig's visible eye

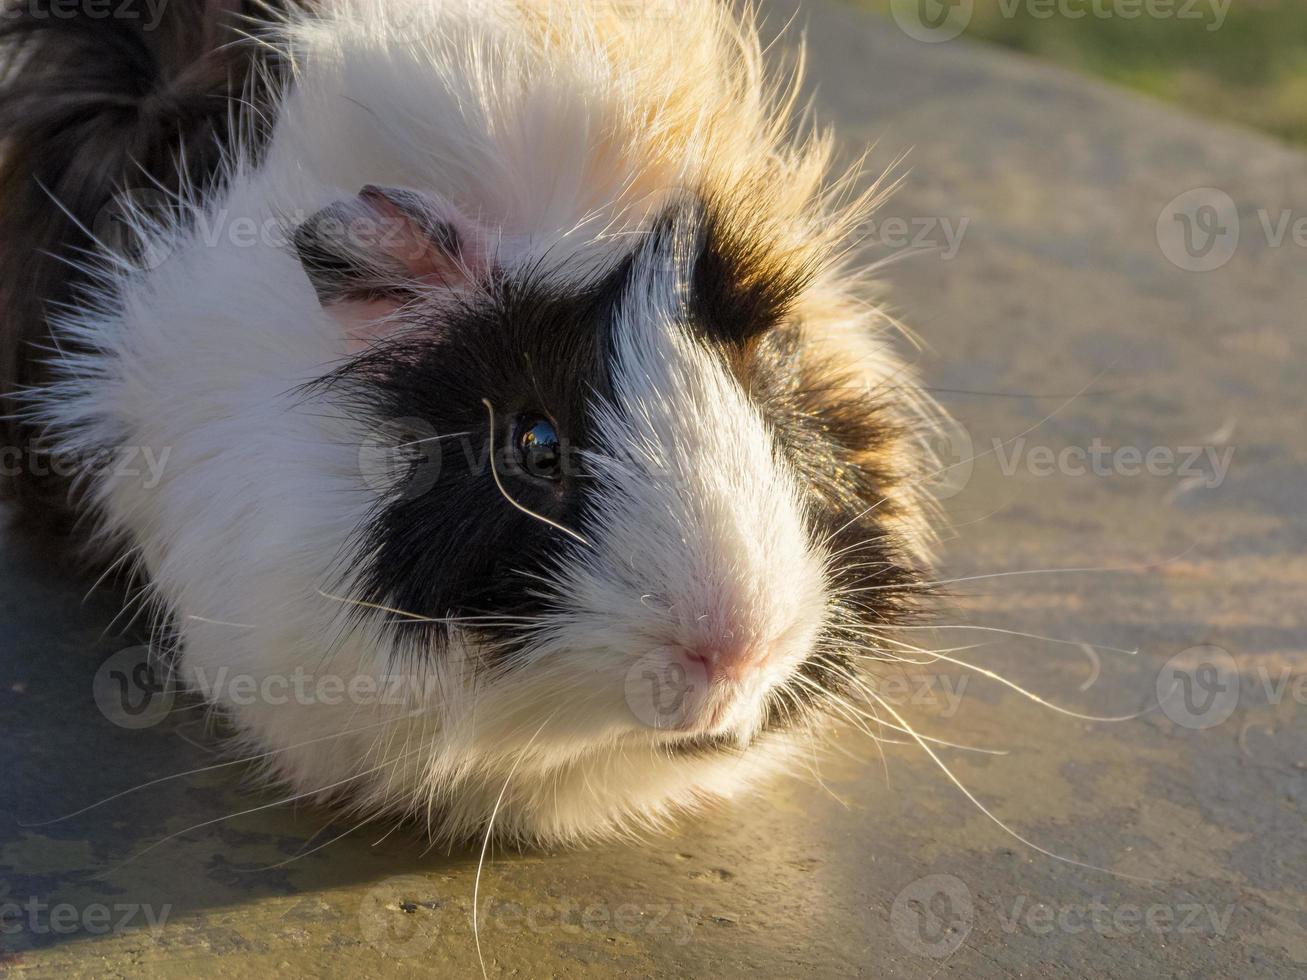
[314,265,627,665]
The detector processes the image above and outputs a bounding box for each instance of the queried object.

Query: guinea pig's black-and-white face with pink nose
[297,185,916,831]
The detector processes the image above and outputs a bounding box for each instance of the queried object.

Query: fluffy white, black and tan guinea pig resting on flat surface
[0,0,933,843]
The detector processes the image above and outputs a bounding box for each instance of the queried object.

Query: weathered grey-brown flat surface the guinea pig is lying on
[0,0,1307,977]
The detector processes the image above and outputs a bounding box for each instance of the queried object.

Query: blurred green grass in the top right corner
[851,0,1307,144]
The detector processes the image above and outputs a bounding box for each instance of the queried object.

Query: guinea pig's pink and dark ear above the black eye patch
[293,186,493,350]
